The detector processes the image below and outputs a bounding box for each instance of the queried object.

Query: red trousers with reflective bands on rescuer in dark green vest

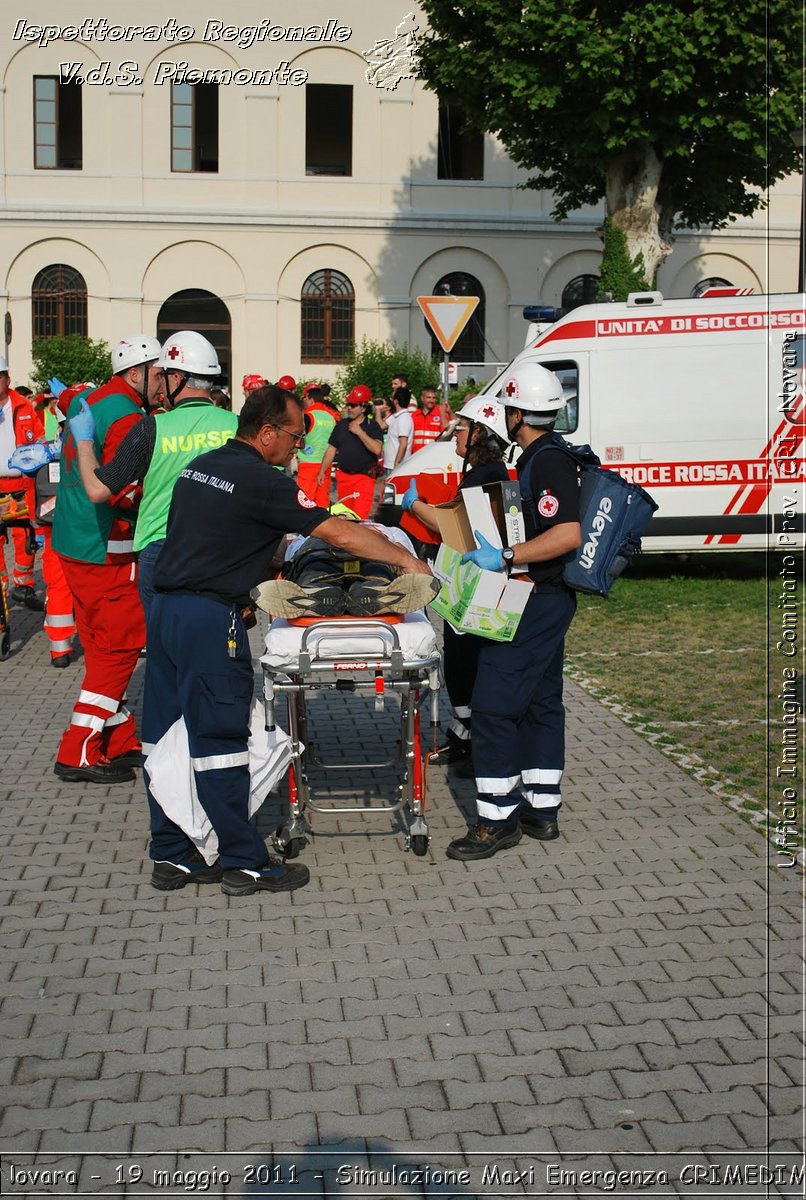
[56,556,145,767]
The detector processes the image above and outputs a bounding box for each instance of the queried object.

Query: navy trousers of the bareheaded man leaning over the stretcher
[143,593,269,870]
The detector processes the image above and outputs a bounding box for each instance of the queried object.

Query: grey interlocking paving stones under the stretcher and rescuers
[0,610,804,1198]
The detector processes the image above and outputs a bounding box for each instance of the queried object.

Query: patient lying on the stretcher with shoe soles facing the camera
[252,504,439,617]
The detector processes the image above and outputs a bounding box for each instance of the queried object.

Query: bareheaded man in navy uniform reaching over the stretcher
[143,386,431,895]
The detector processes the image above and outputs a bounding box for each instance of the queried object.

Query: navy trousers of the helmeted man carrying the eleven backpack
[471,587,577,823]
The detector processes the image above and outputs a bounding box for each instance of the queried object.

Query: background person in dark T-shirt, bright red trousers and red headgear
[317,383,384,521]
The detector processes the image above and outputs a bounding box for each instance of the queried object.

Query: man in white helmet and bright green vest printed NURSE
[71,330,237,620]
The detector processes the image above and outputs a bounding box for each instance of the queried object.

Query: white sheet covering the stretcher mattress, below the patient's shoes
[260,612,437,671]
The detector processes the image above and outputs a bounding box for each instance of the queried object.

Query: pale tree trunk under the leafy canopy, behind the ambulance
[605,144,672,283]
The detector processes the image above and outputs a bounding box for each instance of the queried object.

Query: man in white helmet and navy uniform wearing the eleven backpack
[447,362,582,862]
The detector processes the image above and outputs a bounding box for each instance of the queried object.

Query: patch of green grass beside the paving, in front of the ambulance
[566,553,806,859]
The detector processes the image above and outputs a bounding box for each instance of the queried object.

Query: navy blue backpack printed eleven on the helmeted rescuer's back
[518,433,657,596]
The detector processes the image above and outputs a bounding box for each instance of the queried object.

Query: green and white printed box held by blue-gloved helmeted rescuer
[431,544,531,642]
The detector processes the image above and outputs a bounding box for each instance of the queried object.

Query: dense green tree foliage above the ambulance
[420,0,804,267]
